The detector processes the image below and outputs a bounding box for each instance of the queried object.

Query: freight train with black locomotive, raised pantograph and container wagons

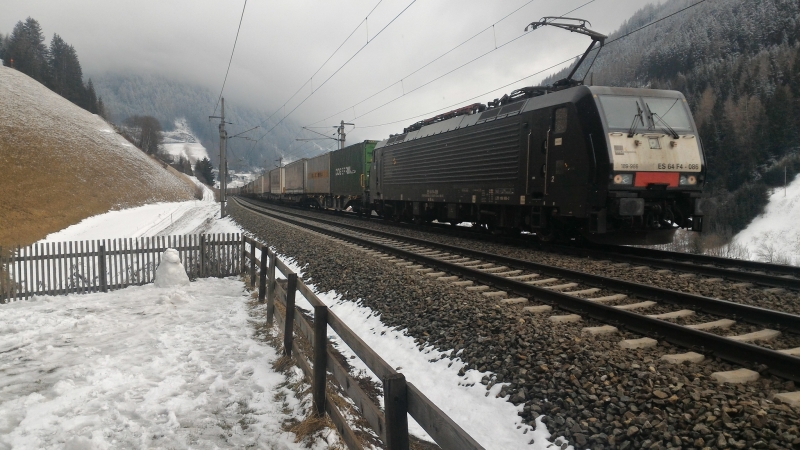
[238,18,706,244]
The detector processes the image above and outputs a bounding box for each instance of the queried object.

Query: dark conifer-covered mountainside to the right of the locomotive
[542,0,800,236]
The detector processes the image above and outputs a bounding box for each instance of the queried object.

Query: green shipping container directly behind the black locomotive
[331,141,378,196]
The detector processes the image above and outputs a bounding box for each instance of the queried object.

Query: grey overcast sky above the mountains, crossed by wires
[0,0,653,142]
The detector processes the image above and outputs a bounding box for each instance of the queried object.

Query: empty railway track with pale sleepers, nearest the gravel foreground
[237,195,800,381]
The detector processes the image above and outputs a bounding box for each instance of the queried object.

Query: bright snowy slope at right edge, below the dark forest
[733,177,800,266]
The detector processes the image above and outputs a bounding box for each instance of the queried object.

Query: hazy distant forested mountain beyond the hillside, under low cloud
[92,73,310,169]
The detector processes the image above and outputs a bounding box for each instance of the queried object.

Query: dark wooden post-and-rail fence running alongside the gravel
[242,237,483,450]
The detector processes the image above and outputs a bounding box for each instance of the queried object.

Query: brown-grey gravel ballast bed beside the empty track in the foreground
[230,202,800,449]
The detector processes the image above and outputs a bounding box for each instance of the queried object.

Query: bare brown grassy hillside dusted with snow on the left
[0,66,194,246]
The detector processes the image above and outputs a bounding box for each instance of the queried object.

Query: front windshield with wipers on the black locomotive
[597,95,692,132]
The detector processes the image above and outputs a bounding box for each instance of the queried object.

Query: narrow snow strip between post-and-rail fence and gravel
[278,251,573,450]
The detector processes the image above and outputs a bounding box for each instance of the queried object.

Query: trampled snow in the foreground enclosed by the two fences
[0,278,337,450]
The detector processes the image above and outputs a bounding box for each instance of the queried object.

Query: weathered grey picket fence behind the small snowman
[0,233,242,303]
